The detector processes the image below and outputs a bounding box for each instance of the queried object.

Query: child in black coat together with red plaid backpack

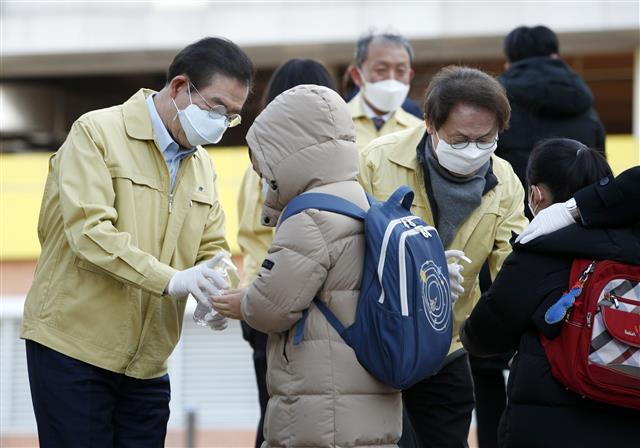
[460,139,640,448]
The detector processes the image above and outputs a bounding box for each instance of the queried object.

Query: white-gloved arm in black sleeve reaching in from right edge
[516,166,640,244]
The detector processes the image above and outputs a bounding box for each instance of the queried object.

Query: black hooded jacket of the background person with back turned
[496,57,605,191]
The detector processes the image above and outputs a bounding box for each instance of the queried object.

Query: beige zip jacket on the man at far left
[21,90,238,378]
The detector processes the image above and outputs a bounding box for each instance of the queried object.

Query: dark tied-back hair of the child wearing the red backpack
[527,138,613,203]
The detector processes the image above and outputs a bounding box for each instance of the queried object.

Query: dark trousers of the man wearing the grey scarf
[402,353,474,448]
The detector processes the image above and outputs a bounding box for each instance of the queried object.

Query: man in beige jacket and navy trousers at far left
[21,38,253,448]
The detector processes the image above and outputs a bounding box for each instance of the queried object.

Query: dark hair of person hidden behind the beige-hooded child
[262,59,336,108]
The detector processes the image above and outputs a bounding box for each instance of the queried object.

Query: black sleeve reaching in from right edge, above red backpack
[574,166,640,227]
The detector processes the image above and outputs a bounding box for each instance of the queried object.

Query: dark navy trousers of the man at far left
[26,341,171,448]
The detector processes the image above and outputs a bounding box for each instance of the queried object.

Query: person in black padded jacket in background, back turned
[470,26,605,448]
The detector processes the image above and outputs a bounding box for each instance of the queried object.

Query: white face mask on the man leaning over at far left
[171,86,227,146]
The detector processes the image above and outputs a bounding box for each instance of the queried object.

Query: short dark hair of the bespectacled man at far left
[167,37,254,88]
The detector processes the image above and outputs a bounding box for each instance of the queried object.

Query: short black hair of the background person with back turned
[504,25,558,62]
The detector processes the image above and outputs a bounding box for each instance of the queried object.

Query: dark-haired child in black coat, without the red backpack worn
[460,139,640,448]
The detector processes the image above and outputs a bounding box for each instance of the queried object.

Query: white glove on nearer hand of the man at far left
[167,252,229,307]
